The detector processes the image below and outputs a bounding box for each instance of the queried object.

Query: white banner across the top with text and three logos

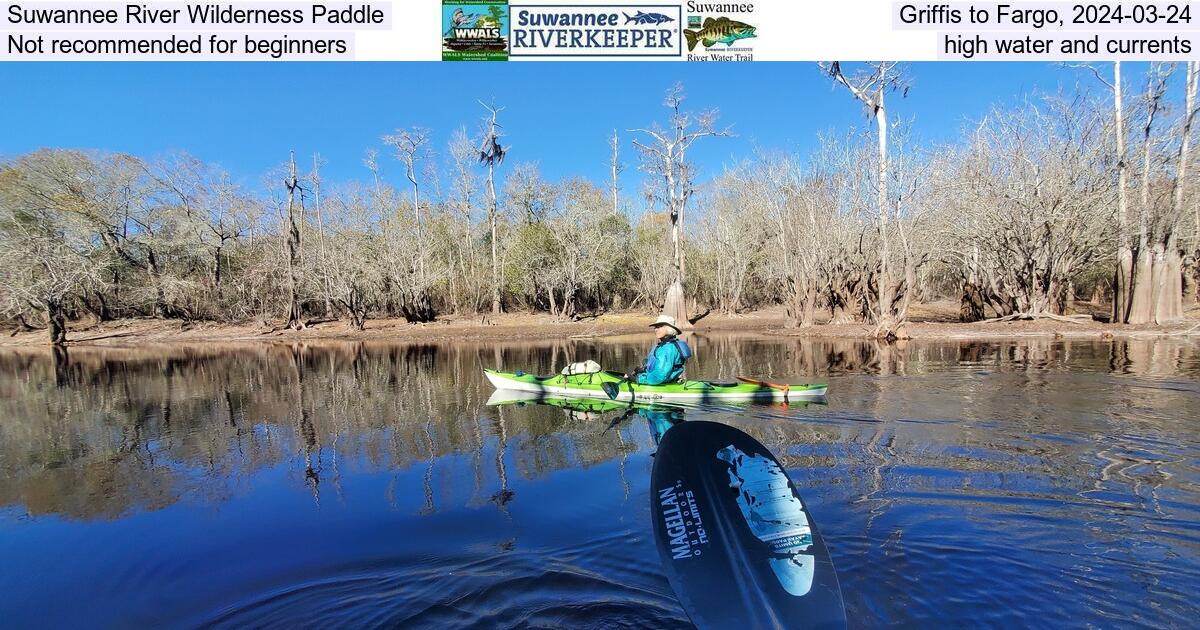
[0,0,1200,61]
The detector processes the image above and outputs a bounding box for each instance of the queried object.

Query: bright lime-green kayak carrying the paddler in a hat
[484,368,828,402]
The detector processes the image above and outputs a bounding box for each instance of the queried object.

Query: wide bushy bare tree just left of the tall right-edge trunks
[930,100,1115,319]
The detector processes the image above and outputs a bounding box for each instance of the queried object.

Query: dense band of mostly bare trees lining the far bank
[7,62,1200,343]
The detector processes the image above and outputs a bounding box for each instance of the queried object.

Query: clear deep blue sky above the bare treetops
[0,62,1161,190]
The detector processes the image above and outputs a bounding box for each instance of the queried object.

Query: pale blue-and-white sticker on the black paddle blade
[716,444,816,596]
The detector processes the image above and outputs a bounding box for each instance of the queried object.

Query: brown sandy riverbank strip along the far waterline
[0,302,1200,347]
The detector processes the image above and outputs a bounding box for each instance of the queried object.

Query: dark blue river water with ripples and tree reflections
[0,335,1200,628]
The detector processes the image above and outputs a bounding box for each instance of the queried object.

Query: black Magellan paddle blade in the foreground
[650,421,846,629]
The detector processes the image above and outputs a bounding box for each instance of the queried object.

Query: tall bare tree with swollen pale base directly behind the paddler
[628,83,730,329]
